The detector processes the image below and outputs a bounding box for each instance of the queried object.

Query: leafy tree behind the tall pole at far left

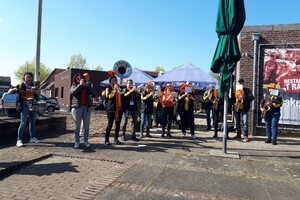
[14,58,51,82]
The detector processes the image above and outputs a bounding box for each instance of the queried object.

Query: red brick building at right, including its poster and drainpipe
[235,24,300,135]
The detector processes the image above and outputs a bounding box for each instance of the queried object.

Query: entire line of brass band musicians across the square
[8,72,283,148]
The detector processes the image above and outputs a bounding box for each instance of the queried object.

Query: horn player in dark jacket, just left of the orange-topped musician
[141,81,155,138]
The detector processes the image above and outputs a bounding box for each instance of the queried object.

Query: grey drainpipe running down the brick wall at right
[251,33,261,136]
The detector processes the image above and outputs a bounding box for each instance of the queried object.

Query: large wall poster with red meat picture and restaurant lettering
[263,49,300,125]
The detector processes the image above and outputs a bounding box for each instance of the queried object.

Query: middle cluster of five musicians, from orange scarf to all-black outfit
[103,72,196,145]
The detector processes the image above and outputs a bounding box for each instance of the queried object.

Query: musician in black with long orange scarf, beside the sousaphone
[105,73,122,145]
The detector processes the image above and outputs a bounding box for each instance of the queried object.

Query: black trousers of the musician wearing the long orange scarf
[105,112,122,142]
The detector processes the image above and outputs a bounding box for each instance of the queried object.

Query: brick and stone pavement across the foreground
[0,110,300,200]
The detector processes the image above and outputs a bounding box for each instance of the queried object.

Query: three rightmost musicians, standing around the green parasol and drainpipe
[203,79,283,145]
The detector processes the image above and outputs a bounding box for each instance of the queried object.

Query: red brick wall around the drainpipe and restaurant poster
[236,24,300,134]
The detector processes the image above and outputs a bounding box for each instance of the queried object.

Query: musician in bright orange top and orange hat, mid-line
[161,84,176,138]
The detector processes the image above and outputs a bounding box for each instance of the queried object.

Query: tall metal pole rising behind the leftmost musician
[35,0,43,84]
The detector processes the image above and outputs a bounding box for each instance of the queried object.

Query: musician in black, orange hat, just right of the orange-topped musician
[177,84,197,139]
